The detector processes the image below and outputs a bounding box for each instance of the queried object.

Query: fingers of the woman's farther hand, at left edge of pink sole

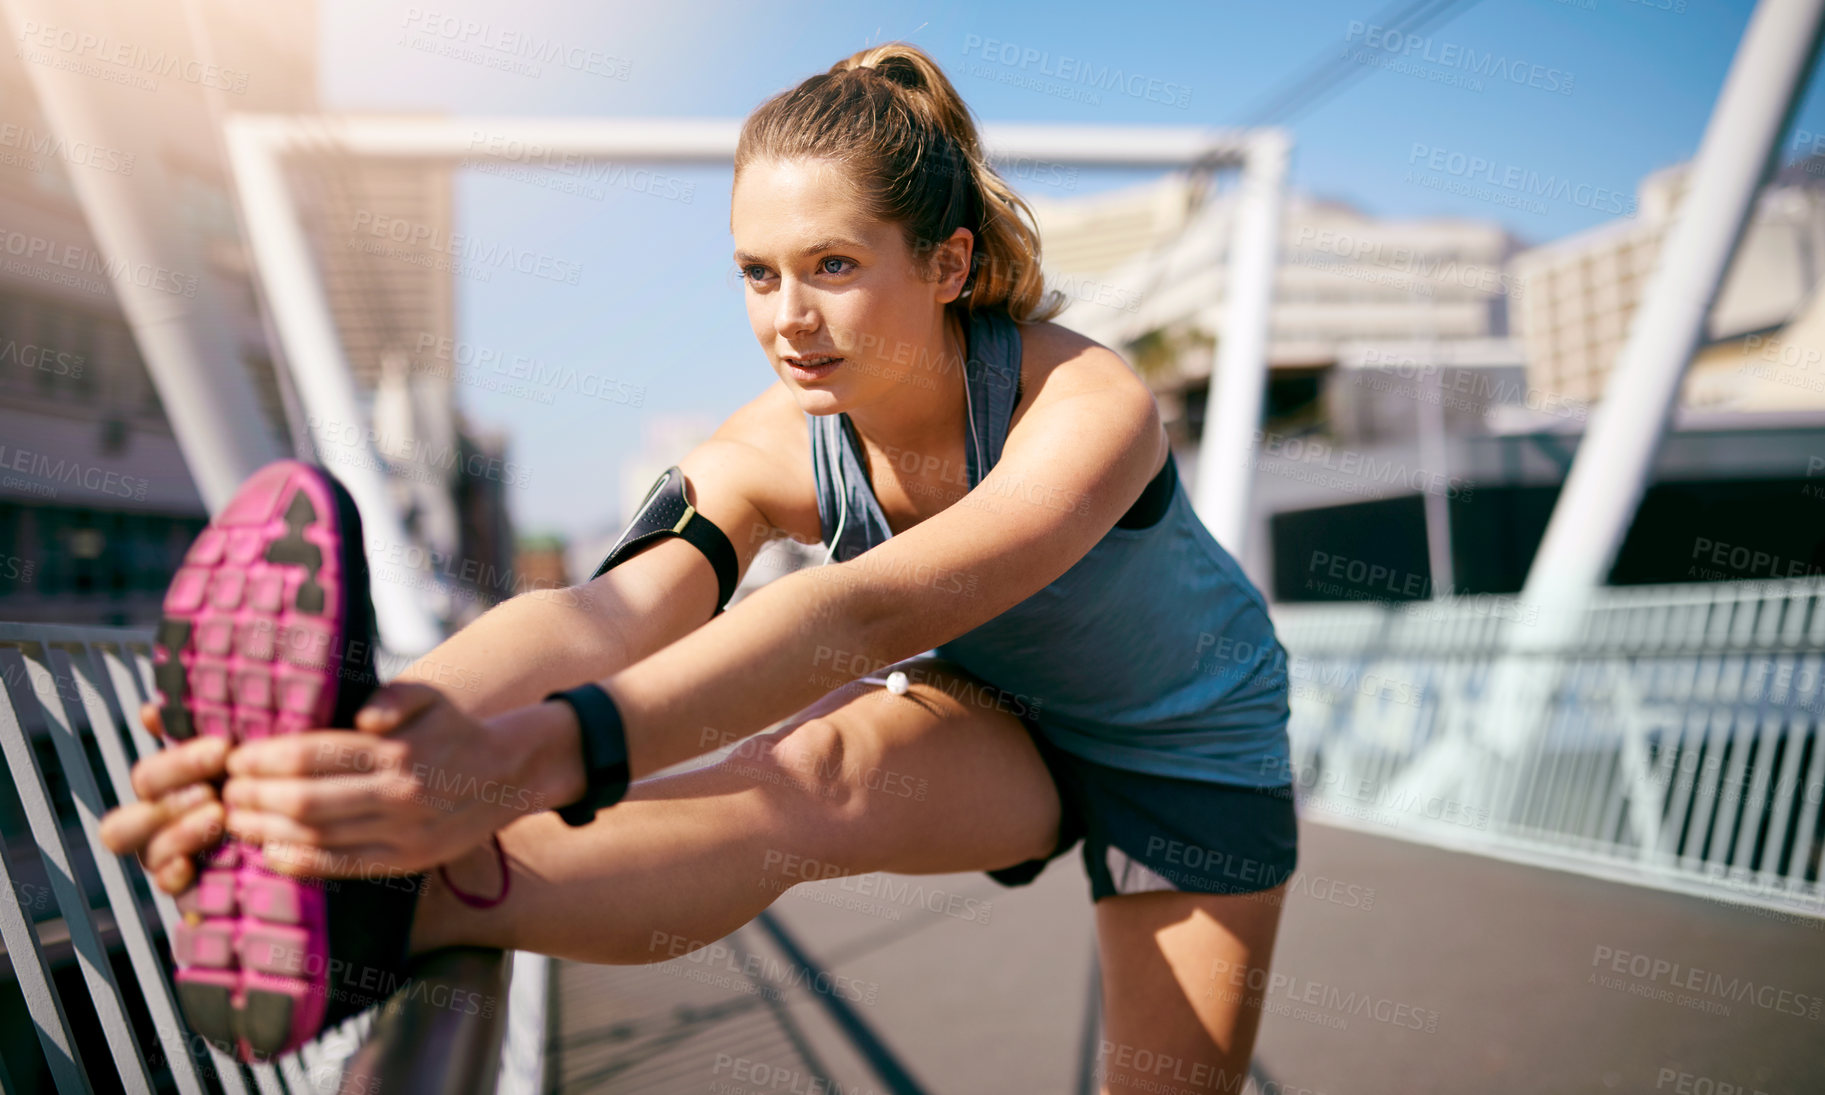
[100,703,228,894]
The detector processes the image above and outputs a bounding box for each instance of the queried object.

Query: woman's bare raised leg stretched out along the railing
[399,661,1060,964]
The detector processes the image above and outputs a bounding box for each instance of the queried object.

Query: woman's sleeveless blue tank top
[807,308,1292,787]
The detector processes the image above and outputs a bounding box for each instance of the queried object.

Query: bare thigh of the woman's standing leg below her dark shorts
[1097,883,1287,1095]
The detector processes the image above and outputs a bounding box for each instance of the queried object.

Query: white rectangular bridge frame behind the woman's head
[213,115,1290,650]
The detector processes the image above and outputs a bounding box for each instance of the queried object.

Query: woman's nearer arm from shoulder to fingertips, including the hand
[217,341,1164,874]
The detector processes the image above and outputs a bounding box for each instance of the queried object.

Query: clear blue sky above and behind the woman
[319,0,1825,537]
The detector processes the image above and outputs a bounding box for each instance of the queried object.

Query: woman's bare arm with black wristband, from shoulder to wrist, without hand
[502,339,1166,803]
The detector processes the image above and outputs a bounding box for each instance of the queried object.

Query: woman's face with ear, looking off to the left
[730,159,971,414]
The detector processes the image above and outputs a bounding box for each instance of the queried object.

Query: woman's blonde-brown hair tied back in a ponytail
[735,42,1066,323]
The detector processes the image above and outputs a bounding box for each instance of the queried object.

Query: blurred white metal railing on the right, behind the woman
[1274,579,1825,916]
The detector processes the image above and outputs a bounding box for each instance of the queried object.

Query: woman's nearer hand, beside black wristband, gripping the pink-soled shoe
[223,683,548,878]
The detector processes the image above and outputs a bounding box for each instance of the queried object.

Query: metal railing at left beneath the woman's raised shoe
[0,624,548,1095]
